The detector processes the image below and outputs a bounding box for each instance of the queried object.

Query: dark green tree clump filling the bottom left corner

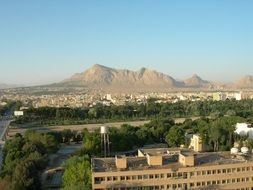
[0,130,58,190]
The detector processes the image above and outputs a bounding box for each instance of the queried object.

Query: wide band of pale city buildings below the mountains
[0,89,253,108]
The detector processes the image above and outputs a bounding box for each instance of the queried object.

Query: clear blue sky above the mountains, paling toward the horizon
[0,0,253,85]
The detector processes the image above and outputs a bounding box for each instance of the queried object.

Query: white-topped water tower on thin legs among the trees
[100,126,110,157]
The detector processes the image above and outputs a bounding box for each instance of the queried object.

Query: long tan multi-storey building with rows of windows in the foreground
[92,148,253,190]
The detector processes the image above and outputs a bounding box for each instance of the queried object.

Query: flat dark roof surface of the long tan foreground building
[92,149,253,172]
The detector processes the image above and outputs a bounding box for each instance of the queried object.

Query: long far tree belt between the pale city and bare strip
[13,100,253,125]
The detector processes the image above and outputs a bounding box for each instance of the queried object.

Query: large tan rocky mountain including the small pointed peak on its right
[61,64,210,91]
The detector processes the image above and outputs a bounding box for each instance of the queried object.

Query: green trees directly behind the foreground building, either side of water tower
[76,116,250,155]
